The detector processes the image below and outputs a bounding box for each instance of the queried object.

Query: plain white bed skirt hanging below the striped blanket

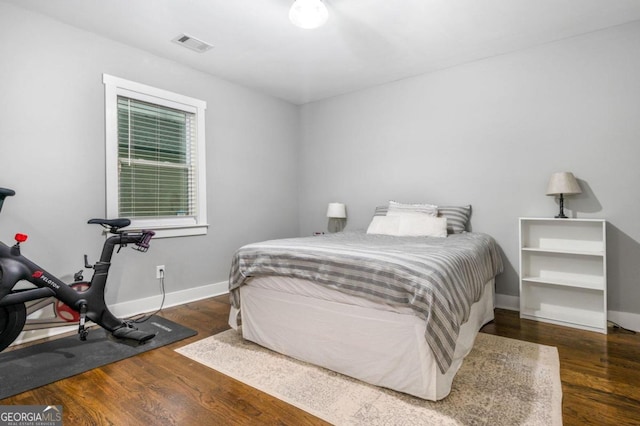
[229,277,494,401]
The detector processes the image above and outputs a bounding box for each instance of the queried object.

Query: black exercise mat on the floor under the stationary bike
[0,315,197,399]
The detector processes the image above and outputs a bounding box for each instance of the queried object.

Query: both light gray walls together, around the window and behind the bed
[0,3,640,322]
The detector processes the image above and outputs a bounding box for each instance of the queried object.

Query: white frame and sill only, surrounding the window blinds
[102,74,209,238]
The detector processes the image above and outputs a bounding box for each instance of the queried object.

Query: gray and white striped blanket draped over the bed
[229,232,503,373]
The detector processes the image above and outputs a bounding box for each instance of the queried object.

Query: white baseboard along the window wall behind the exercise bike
[13,281,229,345]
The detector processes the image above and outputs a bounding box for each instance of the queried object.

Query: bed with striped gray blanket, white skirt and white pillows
[229,205,502,401]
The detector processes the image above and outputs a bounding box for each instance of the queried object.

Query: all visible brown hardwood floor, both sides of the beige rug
[0,296,640,426]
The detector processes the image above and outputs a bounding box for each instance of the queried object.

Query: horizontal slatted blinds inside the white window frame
[118,96,197,218]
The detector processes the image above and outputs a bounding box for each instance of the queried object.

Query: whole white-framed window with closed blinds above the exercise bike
[103,74,207,237]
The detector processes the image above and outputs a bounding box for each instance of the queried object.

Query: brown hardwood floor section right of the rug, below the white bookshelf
[482,309,640,426]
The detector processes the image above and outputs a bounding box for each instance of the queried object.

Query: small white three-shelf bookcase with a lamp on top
[520,218,607,334]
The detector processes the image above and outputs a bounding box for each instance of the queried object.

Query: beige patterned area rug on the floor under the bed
[177,330,562,426]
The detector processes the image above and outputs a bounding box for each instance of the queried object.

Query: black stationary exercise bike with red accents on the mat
[0,188,155,351]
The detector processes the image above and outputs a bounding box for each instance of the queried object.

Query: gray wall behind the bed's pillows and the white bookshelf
[300,22,640,314]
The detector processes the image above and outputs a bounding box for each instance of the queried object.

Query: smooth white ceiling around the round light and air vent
[2,0,640,104]
